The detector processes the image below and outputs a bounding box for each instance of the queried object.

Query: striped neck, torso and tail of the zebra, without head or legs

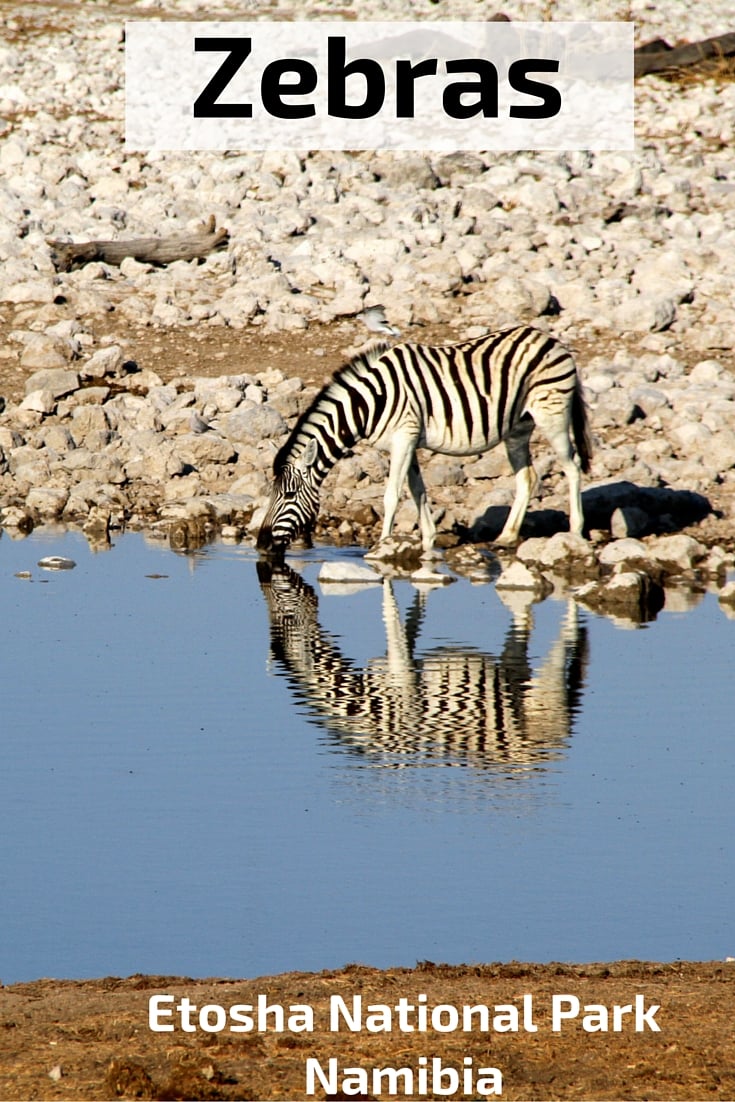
[273,325,591,469]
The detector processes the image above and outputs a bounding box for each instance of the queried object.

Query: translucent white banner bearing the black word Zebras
[126,21,634,151]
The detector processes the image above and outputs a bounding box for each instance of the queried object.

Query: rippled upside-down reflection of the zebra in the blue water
[258,561,588,773]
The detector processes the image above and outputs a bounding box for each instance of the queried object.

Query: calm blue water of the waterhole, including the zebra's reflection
[0,533,735,983]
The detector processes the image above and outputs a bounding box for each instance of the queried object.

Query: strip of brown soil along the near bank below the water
[0,961,735,1100]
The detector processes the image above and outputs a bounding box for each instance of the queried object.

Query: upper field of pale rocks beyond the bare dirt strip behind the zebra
[0,0,735,359]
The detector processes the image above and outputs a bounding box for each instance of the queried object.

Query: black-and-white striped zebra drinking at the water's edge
[257,325,592,555]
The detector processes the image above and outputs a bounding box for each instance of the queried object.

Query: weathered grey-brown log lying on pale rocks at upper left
[46,215,229,272]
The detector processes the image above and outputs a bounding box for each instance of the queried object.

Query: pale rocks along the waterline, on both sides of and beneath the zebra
[0,336,735,612]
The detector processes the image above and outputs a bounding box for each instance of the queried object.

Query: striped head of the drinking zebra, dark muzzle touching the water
[257,439,318,554]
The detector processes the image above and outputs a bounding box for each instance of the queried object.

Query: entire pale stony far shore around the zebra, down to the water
[0,0,735,611]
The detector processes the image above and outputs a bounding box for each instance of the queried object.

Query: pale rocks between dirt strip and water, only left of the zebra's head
[0,345,304,542]
